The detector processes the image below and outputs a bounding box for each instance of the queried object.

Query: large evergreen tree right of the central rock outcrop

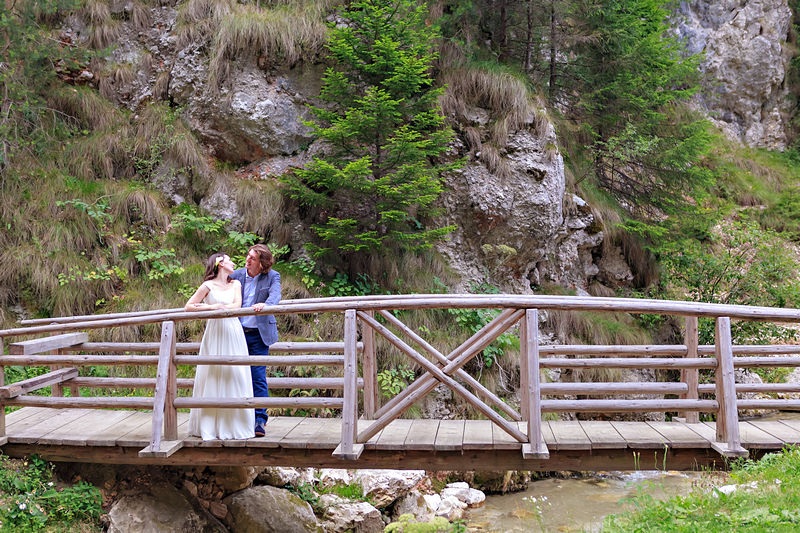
[563,0,710,211]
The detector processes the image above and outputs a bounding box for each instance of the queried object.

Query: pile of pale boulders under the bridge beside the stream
[87,463,494,533]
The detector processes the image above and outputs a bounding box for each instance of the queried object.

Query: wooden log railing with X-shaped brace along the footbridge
[0,295,800,459]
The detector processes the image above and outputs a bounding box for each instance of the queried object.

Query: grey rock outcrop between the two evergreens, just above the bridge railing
[438,117,603,294]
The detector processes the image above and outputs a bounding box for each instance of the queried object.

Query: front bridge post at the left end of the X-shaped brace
[333,309,364,459]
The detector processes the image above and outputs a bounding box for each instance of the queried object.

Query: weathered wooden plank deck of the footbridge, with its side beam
[0,407,800,471]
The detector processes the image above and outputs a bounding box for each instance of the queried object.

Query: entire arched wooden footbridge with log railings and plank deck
[0,295,800,471]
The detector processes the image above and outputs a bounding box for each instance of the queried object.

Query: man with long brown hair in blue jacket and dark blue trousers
[230,244,281,437]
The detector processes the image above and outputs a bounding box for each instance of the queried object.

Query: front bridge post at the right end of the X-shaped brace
[519,309,550,459]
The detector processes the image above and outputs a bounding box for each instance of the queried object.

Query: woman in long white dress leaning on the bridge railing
[184,253,255,440]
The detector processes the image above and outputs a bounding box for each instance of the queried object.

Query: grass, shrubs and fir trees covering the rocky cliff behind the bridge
[0,0,800,328]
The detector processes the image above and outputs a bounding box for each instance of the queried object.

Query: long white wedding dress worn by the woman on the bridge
[189,284,255,440]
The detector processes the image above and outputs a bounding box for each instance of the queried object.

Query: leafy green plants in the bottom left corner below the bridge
[0,455,103,532]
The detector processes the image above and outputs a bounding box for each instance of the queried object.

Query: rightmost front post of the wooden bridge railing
[711,316,748,456]
